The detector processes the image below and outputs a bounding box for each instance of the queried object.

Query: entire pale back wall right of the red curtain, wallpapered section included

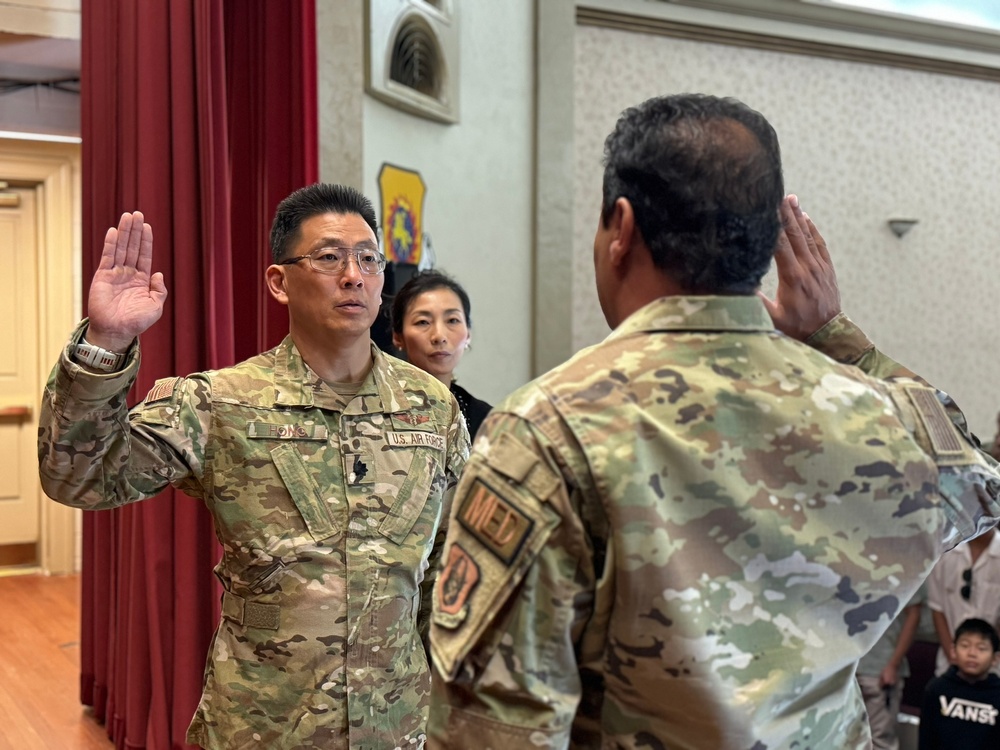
[318,0,1000,435]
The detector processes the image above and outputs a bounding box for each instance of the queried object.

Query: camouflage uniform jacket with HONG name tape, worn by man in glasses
[39,330,469,750]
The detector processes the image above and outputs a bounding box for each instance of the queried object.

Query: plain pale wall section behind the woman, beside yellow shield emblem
[363,0,535,403]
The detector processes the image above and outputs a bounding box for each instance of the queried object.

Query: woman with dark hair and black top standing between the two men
[392,271,492,437]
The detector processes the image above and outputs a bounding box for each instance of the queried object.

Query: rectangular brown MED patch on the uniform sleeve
[458,477,535,565]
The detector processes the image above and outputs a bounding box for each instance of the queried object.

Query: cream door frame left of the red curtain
[0,138,83,575]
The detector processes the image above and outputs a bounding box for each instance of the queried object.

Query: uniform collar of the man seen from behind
[608,295,774,339]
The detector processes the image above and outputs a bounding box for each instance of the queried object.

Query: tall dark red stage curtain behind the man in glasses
[80,0,318,750]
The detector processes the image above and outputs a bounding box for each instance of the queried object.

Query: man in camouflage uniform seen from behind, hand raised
[428,95,1000,750]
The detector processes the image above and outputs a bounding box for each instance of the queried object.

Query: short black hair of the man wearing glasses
[271,182,378,263]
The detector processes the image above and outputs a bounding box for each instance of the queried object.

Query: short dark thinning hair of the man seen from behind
[601,94,784,294]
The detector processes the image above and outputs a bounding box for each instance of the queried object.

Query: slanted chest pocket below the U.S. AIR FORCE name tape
[376,447,441,544]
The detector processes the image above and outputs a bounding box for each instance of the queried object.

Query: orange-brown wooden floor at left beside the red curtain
[0,575,114,750]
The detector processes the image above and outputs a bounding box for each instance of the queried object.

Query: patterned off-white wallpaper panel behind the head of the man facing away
[573,26,1000,437]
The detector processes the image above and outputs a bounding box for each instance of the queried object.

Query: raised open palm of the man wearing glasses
[85,211,167,352]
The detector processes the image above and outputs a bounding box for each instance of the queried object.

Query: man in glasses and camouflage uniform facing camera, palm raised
[39,185,468,750]
